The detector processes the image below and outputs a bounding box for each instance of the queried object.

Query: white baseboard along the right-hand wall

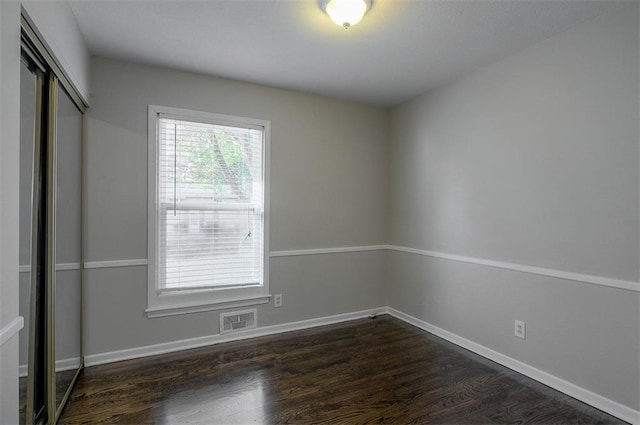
[385,307,640,425]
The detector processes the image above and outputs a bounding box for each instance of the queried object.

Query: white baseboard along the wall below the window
[84,307,386,366]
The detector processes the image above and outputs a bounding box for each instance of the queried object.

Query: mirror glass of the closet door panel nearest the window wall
[55,81,82,414]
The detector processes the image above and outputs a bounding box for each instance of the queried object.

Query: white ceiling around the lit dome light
[69,0,626,105]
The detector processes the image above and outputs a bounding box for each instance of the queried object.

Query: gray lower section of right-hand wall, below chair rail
[388,248,640,411]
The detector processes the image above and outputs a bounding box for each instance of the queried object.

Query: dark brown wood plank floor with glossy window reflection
[60,316,623,424]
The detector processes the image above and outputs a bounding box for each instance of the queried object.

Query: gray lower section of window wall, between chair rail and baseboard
[83,251,386,358]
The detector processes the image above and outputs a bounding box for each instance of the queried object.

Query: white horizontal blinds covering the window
[157,115,264,291]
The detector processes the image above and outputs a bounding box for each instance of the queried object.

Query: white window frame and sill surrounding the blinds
[145,105,271,318]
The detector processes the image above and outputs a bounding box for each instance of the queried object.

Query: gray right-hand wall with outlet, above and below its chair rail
[389,3,640,410]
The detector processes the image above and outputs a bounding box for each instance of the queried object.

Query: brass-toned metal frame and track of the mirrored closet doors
[21,8,87,424]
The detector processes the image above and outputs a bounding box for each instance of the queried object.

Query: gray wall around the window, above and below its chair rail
[84,59,388,355]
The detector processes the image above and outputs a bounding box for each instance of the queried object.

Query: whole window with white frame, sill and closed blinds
[147,106,269,317]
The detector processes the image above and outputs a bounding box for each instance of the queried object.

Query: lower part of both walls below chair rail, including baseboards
[84,250,640,422]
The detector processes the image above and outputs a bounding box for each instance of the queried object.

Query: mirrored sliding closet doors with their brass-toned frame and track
[19,12,85,424]
